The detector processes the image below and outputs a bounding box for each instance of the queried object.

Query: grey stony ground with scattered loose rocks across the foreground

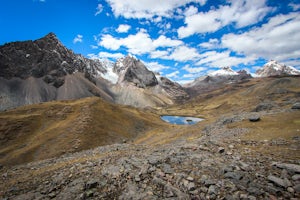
[0,110,300,200]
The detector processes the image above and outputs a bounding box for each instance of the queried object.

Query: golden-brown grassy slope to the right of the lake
[152,77,300,159]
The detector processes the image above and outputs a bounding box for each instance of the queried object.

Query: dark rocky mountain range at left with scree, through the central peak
[0,33,188,110]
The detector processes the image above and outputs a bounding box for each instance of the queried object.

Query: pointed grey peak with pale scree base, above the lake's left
[112,55,189,104]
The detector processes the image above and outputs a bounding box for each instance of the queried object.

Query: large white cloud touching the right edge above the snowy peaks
[222,13,300,61]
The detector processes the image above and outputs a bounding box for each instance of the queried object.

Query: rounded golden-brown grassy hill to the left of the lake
[0,97,166,164]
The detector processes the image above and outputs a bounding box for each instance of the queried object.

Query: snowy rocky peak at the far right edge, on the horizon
[256,60,300,77]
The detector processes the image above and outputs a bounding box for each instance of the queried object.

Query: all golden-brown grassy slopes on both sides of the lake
[0,77,300,164]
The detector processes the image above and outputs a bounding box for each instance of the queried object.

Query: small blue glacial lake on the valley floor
[160,115,204,125]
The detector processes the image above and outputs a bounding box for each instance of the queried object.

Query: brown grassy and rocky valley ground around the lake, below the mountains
[0,74,300,199]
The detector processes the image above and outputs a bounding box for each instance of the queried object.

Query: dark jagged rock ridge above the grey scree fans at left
[0,33,105,87]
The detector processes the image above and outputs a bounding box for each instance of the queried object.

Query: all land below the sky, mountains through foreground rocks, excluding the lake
[0,33,300,200]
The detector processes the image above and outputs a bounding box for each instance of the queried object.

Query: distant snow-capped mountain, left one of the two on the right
[184,67,252,97]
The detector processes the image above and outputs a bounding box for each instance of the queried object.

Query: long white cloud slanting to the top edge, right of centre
[177,0,271,38]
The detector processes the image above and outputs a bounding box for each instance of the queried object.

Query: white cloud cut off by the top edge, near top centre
[107,0,207,19]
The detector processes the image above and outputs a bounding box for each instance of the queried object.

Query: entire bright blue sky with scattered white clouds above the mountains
[0,0,300,84]
